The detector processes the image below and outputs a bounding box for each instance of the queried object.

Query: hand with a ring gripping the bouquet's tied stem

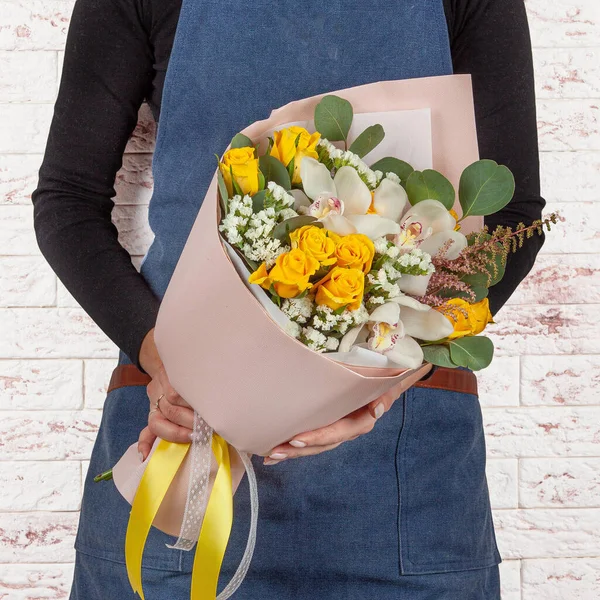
[138,330,194,460]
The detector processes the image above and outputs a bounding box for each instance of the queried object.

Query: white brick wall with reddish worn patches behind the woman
[0,0,600,600]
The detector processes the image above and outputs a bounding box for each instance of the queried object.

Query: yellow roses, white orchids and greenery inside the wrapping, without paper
[218,95,550,371]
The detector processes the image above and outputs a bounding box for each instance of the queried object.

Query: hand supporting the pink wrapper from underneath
[264,374,423,465]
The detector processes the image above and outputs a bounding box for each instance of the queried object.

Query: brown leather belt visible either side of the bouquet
[108,365,477,396]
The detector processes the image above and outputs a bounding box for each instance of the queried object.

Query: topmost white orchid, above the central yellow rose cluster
[294,157,408,240]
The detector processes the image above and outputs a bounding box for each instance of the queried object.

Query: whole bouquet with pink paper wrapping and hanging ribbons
[101,76,548,600]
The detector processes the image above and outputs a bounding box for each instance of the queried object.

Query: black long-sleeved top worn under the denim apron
[32,0,545,366]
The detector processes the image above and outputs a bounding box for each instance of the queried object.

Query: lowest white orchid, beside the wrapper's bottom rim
[339,295,454,369]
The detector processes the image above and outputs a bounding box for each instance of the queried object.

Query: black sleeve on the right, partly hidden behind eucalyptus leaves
[446,0,545,314]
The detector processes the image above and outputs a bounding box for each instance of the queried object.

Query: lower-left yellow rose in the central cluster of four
[248,248,319,298]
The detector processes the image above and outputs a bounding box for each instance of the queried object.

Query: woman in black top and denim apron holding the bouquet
[33,0,544,600]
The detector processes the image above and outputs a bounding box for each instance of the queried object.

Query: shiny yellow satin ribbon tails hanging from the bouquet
[125,433,233,600]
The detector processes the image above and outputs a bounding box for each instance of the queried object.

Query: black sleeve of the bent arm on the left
[32,0,159,366]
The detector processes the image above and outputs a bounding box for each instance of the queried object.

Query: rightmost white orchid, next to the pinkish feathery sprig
[394,200,468,296]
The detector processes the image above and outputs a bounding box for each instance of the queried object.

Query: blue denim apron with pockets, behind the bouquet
[71,0,500,600]
